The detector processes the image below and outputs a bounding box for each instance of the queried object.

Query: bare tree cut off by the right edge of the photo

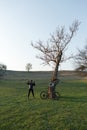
[74,45,87,71]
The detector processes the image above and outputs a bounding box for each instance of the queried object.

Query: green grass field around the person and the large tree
[0,72,87,130]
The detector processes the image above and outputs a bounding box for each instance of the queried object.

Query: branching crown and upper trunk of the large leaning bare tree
[31,20,80,80]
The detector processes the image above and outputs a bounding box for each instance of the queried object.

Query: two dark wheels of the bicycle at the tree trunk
[40,91,60,100]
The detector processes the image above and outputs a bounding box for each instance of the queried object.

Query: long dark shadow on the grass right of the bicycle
[60,96,87,103]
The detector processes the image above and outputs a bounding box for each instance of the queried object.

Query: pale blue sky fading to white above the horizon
[0,0,87,71]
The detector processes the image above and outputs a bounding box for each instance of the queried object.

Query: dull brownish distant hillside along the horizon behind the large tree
[3,70,87,80]
